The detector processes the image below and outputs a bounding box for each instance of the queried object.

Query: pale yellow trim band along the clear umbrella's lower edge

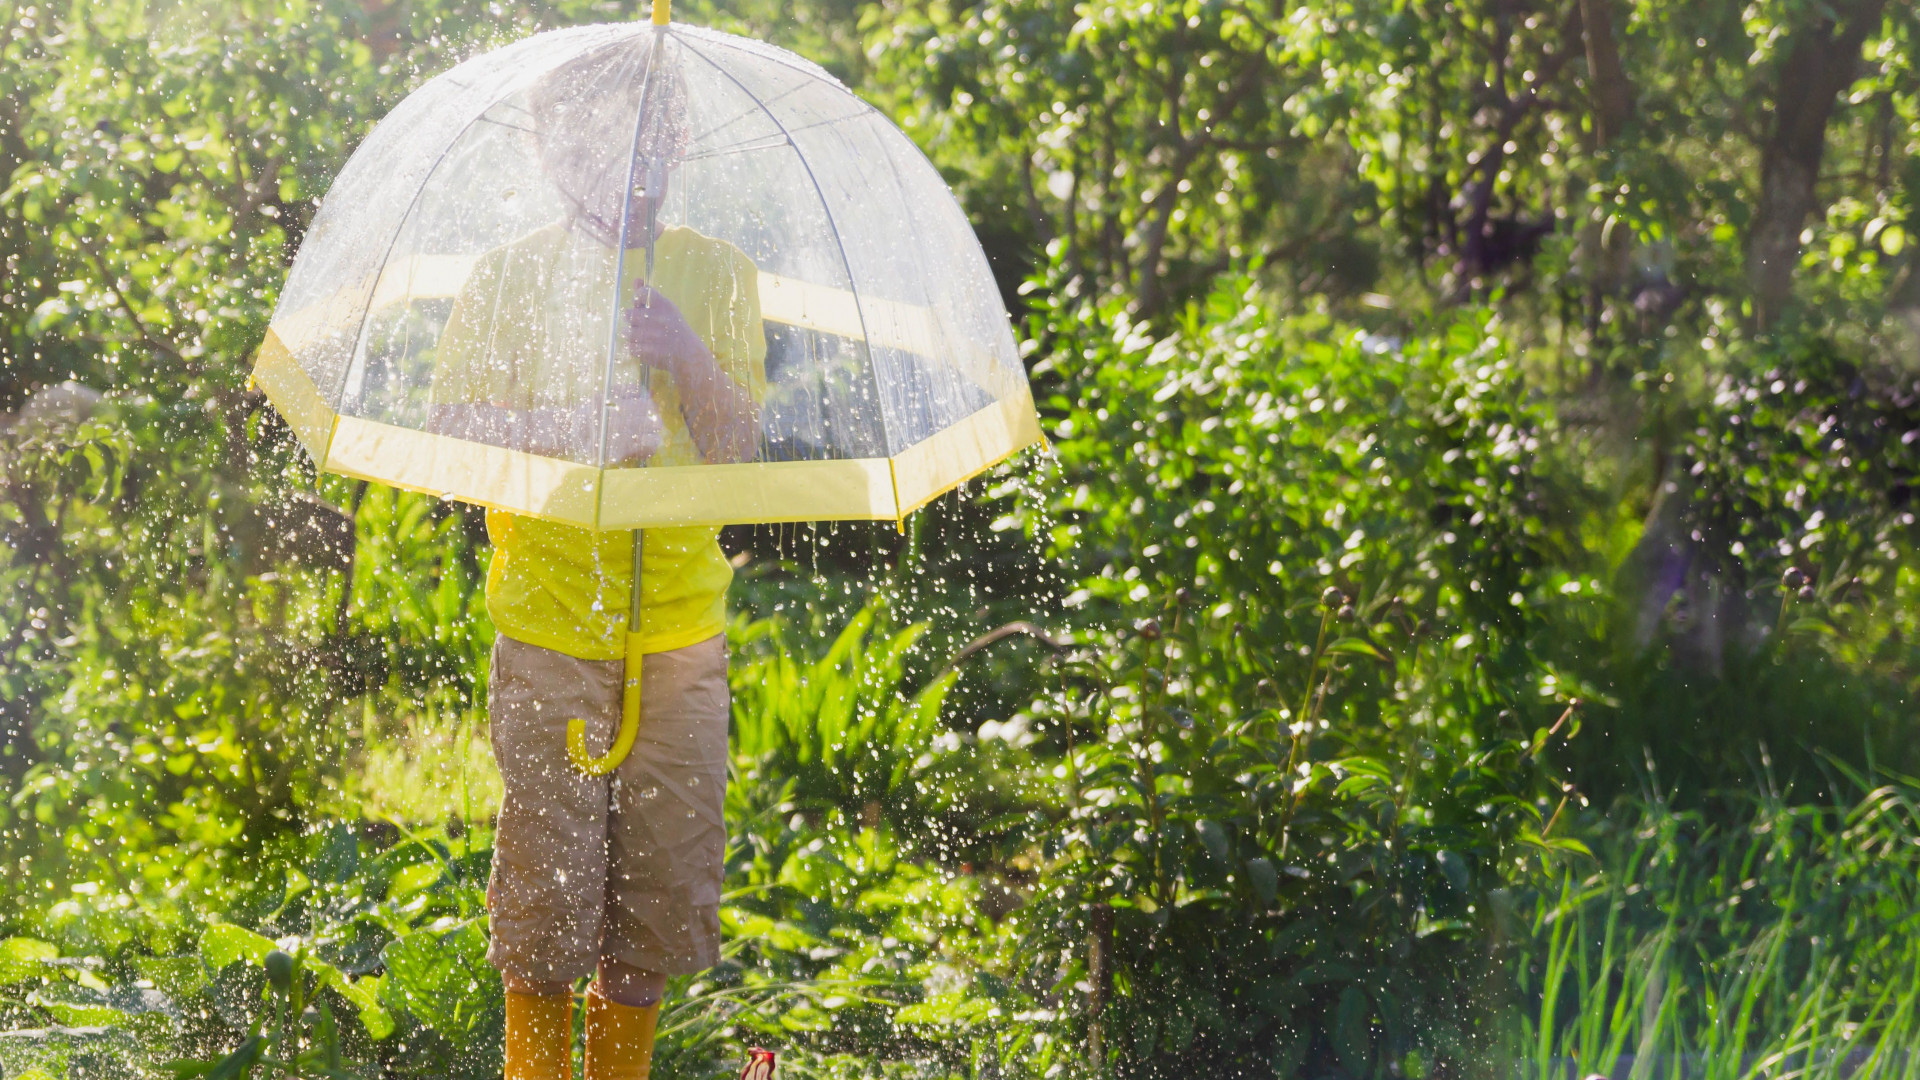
[253,331,1041,528]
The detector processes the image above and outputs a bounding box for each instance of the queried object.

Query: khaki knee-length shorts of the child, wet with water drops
[488,636,728,982]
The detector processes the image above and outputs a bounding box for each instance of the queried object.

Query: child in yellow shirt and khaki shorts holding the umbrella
[430,44,766,1080]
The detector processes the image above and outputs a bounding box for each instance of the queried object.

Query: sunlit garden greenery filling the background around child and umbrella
[0,0,1920,1080]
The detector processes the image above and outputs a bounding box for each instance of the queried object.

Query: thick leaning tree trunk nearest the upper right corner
[1747,0,1885,327]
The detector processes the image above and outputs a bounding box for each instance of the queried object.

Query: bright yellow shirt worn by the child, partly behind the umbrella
[432,225,766,659]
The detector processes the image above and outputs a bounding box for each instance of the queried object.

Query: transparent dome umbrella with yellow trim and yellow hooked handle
[253,0,1041,773]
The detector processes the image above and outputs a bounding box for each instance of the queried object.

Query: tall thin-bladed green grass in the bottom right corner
[1509,771,1920,1080]
